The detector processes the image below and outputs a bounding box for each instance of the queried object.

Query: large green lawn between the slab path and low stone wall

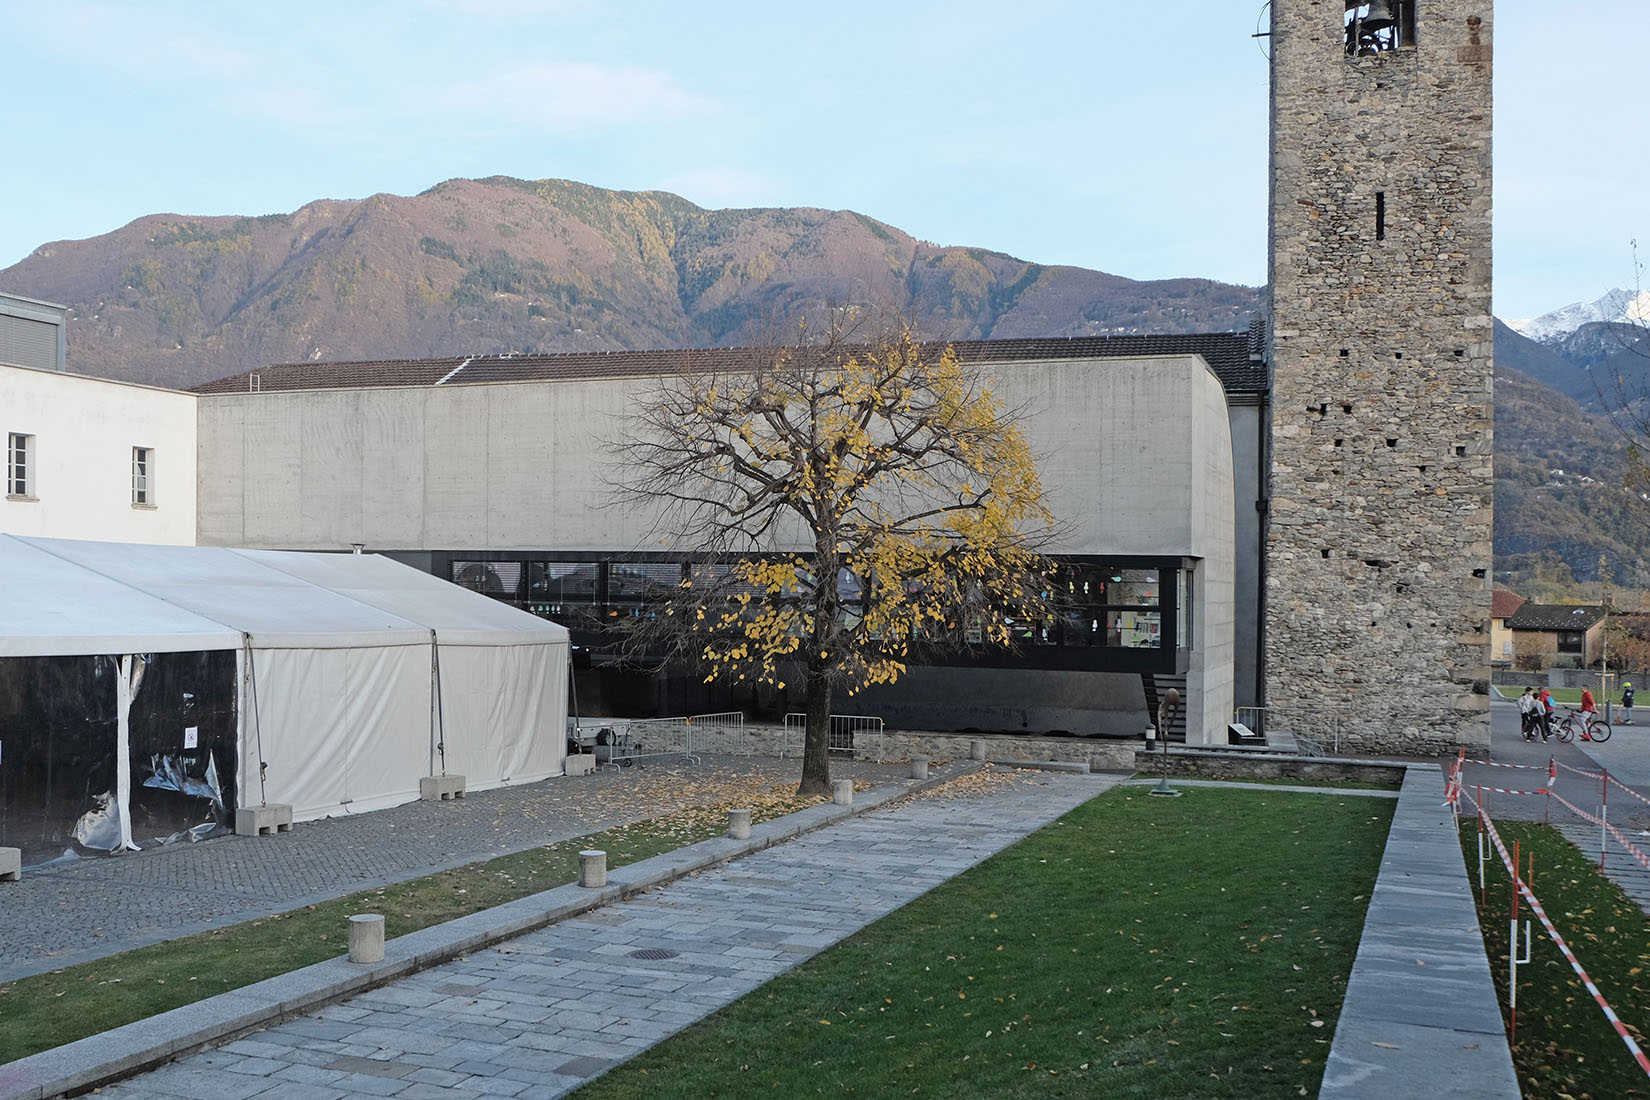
[573,787,1394,1100]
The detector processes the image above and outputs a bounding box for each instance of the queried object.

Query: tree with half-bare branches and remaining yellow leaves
[617,328,1054,793]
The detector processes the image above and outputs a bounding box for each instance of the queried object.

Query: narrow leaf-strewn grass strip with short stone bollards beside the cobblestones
[0,785,822,1064]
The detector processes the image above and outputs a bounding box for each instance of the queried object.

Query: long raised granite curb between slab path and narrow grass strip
[0,760,982,1100]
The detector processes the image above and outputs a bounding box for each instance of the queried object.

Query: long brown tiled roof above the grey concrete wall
[193,333,1266,404]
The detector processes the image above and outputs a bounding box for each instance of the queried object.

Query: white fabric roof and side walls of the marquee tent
[0,536,569,846]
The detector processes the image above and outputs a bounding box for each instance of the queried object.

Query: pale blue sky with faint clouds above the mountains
[0,0,1650,320]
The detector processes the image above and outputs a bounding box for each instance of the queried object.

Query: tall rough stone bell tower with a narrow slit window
[1264,0,1493,754]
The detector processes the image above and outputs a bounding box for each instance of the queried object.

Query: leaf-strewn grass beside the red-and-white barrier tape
[1460,821,1650,1100]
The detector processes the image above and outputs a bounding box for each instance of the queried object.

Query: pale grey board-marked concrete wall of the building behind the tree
[200,356,1234,744]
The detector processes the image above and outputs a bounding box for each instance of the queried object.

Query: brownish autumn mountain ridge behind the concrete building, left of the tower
[0,176,1259,388]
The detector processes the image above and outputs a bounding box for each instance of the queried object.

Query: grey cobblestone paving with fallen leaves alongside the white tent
[0,757,909,981]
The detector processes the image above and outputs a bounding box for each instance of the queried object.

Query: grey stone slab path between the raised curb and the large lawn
[87,773,1117,1100]
